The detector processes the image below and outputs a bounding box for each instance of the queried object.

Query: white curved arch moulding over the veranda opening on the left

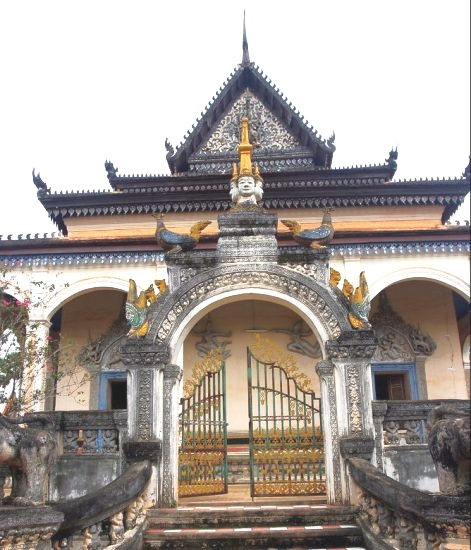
[43,277,129,319]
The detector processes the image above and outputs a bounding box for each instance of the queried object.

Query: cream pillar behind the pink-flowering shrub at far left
[21,316,51,412]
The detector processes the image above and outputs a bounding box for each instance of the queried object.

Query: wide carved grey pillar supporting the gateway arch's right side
[326,330,376,502]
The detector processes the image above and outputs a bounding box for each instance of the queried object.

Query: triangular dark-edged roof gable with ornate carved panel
[167,63,335,174]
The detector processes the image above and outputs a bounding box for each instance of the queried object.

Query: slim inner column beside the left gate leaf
[159,365,183,508]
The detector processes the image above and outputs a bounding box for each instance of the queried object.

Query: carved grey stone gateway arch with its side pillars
[123,260,380,505]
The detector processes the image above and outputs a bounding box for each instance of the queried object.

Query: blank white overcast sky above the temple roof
[0,0,470,238]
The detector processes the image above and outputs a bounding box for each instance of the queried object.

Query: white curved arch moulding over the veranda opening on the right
[369,266,471,301]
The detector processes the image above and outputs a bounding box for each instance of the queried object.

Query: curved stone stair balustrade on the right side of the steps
[348,458,471,550]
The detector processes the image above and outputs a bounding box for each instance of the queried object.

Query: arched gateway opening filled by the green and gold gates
[175,300,325,497]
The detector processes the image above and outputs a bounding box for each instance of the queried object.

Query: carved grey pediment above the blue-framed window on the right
[370,291,437,362]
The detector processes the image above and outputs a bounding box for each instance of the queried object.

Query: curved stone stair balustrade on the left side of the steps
[0,461,151,550]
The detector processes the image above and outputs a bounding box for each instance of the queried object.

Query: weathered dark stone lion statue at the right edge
[427,405,471,495]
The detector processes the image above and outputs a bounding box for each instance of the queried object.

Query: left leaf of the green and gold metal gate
[178,351,227,497]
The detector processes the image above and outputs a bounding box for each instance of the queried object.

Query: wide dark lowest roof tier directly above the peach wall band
[39,171,469,235]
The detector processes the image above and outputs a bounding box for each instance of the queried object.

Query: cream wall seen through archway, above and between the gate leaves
[183,300,321,434]
